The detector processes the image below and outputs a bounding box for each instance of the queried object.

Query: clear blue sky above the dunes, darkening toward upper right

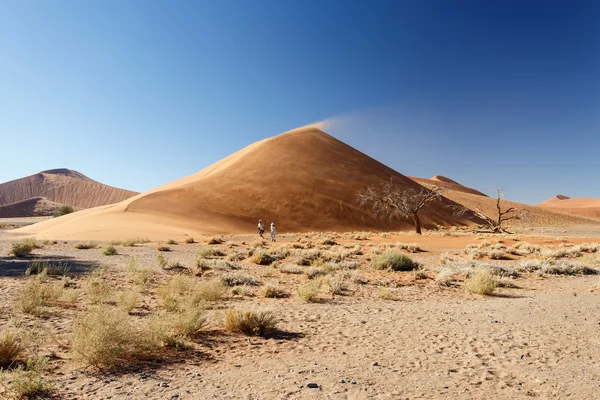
[0,0,600,203]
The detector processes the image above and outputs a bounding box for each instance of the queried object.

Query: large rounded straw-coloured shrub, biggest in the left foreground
[71,306,144,368]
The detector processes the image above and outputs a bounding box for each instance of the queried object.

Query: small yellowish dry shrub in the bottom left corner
[0,357,52,399]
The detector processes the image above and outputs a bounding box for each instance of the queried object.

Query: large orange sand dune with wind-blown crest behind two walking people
[15,127,482,239]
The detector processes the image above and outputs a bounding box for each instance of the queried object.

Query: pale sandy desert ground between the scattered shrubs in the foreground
[0,230,600,399]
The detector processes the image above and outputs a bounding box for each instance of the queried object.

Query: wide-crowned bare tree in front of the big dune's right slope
[357,179,442,235]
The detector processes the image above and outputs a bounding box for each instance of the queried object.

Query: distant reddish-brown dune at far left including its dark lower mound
[0,168,137,217]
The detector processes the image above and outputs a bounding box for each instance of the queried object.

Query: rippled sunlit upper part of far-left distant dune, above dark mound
[0,169,137,212]
